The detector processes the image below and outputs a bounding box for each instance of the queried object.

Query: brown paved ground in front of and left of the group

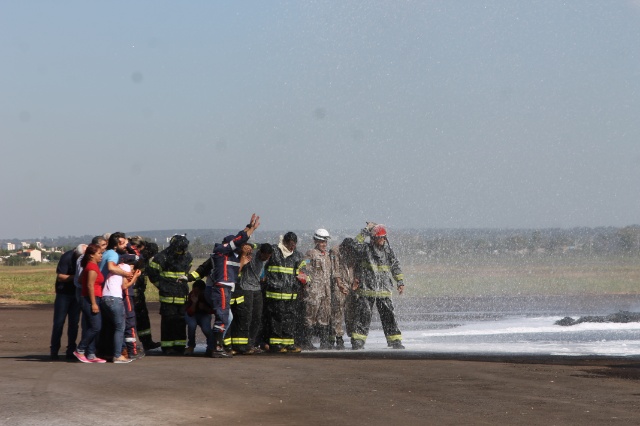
[0,305,640,425]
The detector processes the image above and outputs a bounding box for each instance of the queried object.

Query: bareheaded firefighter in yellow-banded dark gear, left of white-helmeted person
[265,232,307,353]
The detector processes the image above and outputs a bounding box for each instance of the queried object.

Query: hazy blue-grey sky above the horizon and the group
[0,0,640,239]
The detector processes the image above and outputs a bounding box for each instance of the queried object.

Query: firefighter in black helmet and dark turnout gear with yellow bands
[147,235,193,355]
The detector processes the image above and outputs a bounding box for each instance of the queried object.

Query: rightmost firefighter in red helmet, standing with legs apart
[351,222,404,349]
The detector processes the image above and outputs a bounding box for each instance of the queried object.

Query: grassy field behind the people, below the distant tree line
[0,256,640,303]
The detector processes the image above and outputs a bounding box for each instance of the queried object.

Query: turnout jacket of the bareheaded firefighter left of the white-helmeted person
[265,244,306,300]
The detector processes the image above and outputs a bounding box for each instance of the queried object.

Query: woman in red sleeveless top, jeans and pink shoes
[73,244,106,363]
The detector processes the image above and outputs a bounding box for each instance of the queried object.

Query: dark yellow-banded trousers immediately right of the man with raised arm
[230,289,262,352]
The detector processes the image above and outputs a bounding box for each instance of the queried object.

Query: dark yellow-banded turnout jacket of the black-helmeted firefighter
[146,247,193,305]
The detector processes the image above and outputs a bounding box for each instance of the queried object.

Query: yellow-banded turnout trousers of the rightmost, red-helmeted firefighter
[351,293,402,345]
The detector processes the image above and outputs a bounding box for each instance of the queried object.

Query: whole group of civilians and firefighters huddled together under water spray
[51,214,404,363]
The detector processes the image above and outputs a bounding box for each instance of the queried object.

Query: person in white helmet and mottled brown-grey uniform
[301,228,334,350]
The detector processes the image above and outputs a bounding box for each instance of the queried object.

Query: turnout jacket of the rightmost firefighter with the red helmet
[354,235,404,297]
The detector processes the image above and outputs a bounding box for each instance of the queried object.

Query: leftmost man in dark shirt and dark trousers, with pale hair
[51,244,87,360]
